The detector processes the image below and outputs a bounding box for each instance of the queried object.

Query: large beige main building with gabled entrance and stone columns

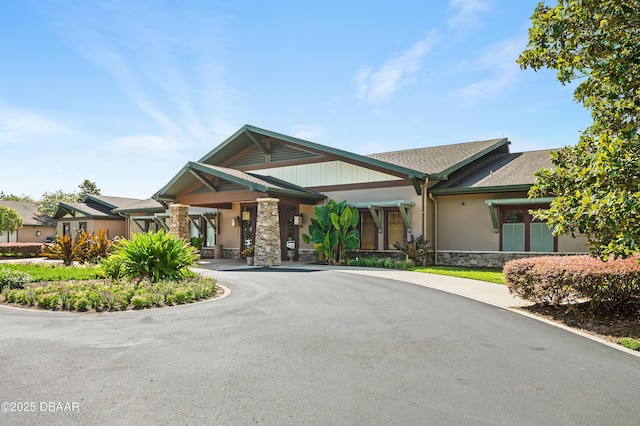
[152,125,586,266]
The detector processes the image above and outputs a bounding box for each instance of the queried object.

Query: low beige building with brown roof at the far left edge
[0,200,56,243]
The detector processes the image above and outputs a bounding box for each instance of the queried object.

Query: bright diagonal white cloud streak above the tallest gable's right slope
[356,31,437,105]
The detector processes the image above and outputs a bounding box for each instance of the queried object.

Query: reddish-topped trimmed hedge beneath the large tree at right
[504,256,640,308]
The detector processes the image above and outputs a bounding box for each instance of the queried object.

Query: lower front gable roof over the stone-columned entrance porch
[153,161,326,200]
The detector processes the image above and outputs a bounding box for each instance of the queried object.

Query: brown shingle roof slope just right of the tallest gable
[367,138,509,175]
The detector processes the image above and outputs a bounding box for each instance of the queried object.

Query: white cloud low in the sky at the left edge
[0,104,69,144]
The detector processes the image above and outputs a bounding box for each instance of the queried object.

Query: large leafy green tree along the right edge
[518,0,640,259]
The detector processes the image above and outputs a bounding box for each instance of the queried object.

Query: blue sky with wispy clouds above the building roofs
[0,0,590,199]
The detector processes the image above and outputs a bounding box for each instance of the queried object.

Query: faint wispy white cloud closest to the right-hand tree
[453,37,526,106]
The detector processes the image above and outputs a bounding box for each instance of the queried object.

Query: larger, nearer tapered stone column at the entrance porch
[253,198,282,267]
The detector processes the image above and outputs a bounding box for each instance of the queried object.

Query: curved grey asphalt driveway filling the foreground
[0,271,640,425]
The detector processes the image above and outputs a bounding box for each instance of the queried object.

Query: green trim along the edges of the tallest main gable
[198,124,428,180]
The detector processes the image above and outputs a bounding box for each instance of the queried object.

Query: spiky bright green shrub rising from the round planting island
[107,230,198,282]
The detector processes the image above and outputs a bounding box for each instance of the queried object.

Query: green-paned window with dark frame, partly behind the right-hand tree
[500,206,558,252]
